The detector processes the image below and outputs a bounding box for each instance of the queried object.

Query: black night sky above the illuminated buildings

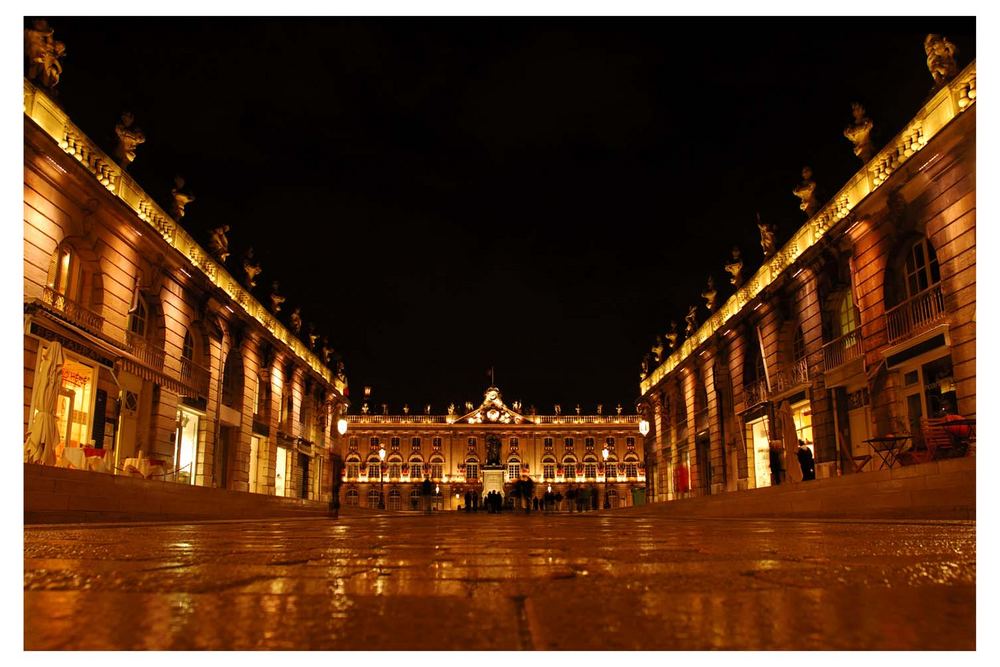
[39,17,975,412]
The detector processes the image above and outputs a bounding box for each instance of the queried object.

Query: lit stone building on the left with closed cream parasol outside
[24,74,347,500]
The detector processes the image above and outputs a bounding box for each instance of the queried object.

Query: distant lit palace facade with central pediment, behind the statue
[341,387,645,510]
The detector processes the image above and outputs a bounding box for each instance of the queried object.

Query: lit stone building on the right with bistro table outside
[640,60,976,501]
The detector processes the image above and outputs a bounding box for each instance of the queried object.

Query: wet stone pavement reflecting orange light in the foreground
[24,513,976,650]
